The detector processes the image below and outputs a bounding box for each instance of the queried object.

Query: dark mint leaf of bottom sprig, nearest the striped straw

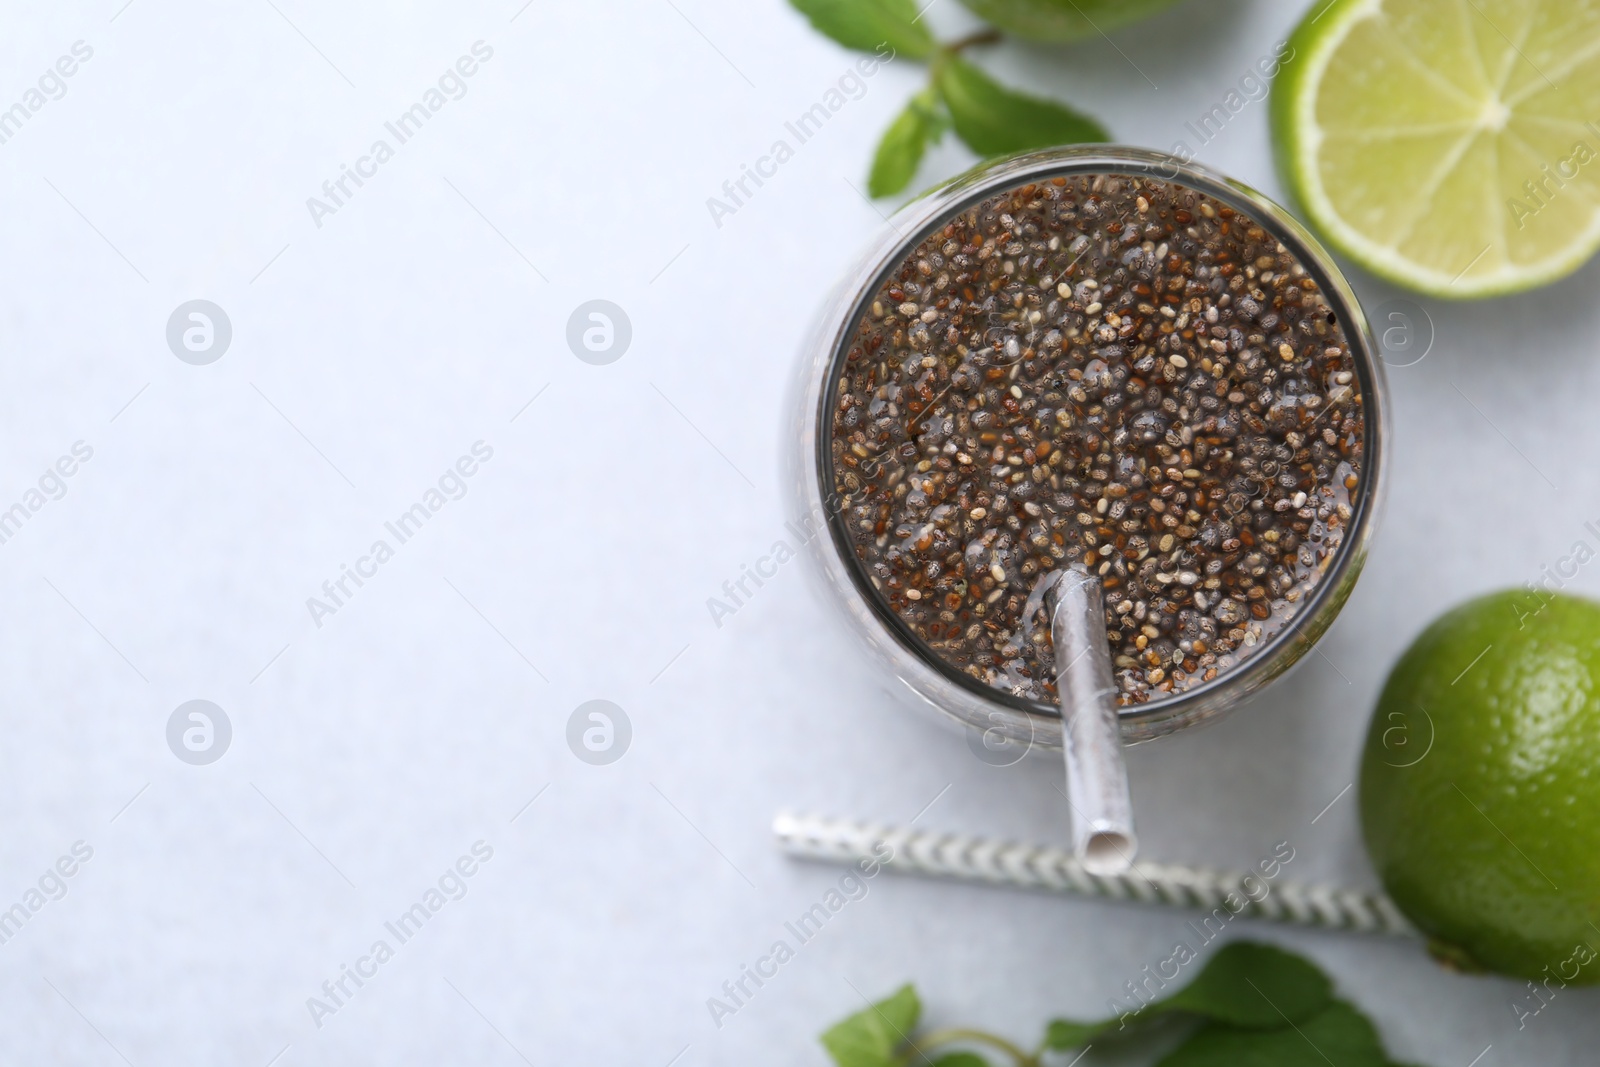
[1045,941,1342,1049]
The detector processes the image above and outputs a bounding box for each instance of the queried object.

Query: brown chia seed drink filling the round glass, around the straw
[813,150,1376,739]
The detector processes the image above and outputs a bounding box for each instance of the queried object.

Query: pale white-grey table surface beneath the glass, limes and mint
[0,0,1600,1067]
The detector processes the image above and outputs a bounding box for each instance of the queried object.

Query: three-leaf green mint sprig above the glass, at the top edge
[789,0,1110,197]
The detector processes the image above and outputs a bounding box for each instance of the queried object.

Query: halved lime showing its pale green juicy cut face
[1272,0,1600,299]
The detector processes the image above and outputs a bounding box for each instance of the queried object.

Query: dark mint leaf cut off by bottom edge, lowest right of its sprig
[1155,1000,1392,1067]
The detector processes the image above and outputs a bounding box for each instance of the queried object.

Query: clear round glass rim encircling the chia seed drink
[813,144,1387,728]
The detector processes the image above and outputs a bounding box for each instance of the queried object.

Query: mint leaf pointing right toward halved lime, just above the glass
[934,56,1110,155]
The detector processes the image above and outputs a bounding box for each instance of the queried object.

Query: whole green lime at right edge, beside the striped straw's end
[1360,590,1600,984]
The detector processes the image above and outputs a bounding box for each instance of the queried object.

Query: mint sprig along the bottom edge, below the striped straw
[822,941,1420,1067]
